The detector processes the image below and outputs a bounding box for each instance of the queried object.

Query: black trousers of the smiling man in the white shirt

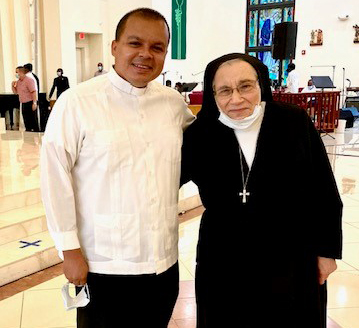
[77,263,179,328]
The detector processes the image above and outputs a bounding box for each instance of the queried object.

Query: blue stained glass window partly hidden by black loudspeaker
[246,0,295,83]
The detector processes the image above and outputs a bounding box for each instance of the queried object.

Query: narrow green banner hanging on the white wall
[172,0,187,59]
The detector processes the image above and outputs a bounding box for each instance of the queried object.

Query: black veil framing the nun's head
[198,53,273,119]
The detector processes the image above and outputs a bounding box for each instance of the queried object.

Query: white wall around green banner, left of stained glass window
[152,0,246,90]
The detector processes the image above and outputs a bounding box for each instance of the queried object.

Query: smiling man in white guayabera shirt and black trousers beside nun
[41,8,194,328]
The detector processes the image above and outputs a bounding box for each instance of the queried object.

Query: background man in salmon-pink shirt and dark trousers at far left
[11,66,39,132]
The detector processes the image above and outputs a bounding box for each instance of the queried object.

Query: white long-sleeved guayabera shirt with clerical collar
[41,68,194,274]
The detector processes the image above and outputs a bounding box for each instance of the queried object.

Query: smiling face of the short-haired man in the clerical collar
[112,15,169,88]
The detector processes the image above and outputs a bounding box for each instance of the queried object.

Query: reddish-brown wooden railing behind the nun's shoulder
[273,91,340,132]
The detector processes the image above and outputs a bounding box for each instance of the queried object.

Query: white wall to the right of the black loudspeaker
[294,0,359,89]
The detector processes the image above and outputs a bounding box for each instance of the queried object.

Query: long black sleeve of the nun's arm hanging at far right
[306,113,343,259]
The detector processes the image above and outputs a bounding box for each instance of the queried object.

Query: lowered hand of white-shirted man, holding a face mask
[63,248,89,286]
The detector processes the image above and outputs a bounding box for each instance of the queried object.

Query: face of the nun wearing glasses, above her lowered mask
[213,60,261,120]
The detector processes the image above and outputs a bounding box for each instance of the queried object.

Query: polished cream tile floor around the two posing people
[0,122,359,328]
